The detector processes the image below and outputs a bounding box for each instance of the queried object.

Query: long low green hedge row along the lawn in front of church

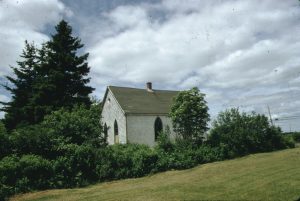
[0,144,223,200]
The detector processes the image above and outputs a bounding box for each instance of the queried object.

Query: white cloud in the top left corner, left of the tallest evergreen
[0,0,71,76]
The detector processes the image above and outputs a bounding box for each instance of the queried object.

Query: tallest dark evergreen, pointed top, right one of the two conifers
[45,20,93,107]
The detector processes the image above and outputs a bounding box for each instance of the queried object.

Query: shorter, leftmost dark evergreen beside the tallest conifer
[1,41,37,129]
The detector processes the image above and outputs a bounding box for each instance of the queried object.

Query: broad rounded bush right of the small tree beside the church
[209,109,287,157]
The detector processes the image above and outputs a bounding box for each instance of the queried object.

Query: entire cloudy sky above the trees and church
[0,0,300,131]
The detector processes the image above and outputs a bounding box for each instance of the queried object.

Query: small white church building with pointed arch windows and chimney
[101,82,178,146]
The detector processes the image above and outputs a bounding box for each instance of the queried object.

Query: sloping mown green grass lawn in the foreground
[11,148,300,201]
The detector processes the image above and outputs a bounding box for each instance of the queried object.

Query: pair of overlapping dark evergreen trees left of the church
[3,20,94,129]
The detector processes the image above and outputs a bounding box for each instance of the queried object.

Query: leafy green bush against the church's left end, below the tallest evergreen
[41,104,106,147]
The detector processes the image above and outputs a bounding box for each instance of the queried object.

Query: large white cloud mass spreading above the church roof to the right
[87,0,300,130]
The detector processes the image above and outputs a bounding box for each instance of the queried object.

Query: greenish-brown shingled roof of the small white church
[108,86,179,114]
